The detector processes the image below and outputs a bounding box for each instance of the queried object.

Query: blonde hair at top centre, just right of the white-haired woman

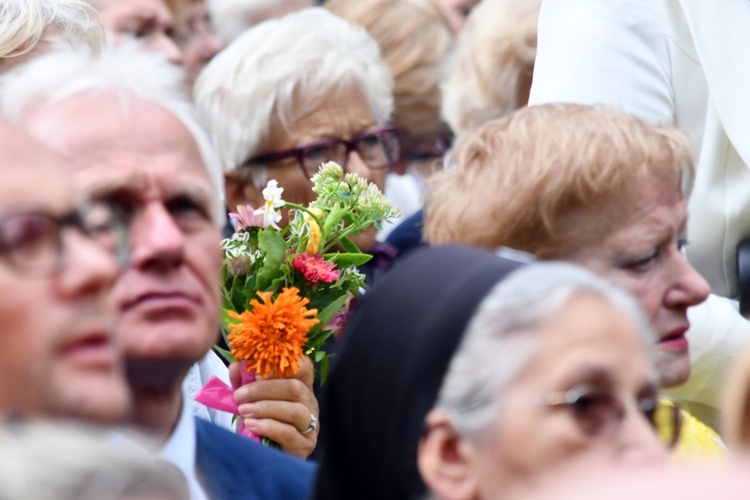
[325,0,453,139]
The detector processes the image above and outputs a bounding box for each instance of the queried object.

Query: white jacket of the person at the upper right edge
[530,0,750,418]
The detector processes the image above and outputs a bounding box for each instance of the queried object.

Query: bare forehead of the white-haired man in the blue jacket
[16,93,219,221]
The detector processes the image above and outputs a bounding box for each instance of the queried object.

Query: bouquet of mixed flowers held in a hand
[199,162,399,438]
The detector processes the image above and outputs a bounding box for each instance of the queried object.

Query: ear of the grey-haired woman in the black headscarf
[417,410,479,500]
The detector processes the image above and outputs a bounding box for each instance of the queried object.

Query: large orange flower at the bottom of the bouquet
[228,288,318,378]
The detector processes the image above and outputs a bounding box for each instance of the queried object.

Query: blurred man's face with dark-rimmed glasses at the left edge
[0,122,130,422]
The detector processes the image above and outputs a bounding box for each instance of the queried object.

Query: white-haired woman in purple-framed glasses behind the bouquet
[194,7,399,258]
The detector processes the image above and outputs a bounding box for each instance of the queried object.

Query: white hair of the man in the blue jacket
[0,44,224,224]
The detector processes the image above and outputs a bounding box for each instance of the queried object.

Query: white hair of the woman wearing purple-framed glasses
[195,7,393,176]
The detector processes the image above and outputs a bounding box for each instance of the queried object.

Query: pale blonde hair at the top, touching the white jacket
[442,0,541,135]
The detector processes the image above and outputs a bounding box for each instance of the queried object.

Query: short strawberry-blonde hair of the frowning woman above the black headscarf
[424,104,693,258]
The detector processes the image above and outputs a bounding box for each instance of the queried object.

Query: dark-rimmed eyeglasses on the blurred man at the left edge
[0,202,128,277]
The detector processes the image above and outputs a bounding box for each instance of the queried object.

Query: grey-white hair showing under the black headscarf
[436,262,655,436]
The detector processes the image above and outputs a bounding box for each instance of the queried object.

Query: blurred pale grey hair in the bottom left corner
[0,421,189,500]
